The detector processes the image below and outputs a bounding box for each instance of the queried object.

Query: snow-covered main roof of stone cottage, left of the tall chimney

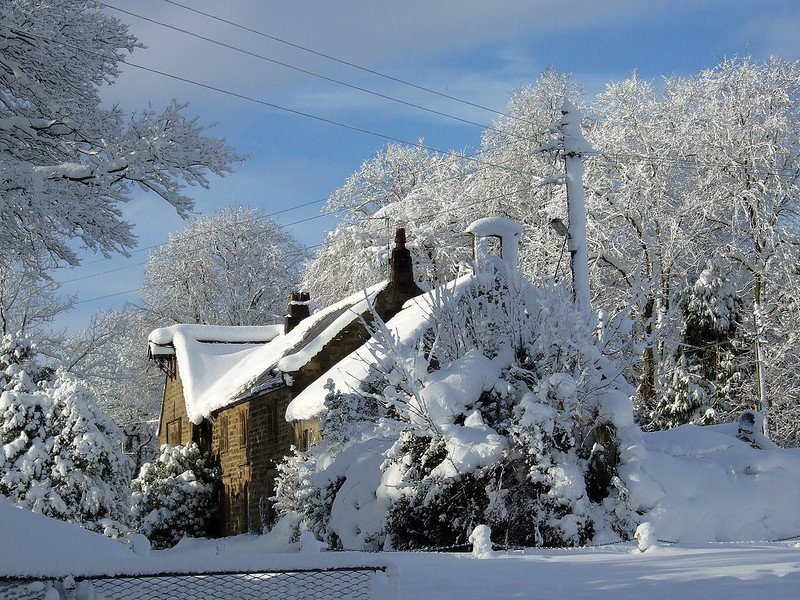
[162,281,388,423]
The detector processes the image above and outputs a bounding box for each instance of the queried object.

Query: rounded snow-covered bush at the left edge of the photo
[0,336,130,536]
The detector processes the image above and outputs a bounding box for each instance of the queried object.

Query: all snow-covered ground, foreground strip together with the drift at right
[0,425,800,600]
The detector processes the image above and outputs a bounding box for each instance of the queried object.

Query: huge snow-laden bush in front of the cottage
[277,264,635,549]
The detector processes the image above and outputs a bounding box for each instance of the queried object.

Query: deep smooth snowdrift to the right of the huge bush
[620,424,800,543]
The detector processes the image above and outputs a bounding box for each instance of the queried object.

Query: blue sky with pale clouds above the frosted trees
[53,0,800,329]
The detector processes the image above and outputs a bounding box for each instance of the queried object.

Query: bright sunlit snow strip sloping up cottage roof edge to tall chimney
[185,281,389,423]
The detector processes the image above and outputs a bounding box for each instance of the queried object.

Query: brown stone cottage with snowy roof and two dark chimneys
[149,229,422,535]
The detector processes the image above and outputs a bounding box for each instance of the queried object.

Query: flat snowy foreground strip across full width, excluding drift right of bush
[0,503,800,600]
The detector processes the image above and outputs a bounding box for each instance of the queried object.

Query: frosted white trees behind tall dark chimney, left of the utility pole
[303,72,578,304]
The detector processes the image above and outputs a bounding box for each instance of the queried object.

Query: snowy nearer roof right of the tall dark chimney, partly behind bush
[286,274,474,421]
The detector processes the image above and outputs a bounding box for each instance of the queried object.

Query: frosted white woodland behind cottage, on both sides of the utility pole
[305,58,800,439]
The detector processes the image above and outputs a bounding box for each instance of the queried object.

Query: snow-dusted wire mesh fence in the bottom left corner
[0,567,388,600]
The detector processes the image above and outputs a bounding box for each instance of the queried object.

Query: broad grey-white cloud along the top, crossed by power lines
[97,0,673,106]
